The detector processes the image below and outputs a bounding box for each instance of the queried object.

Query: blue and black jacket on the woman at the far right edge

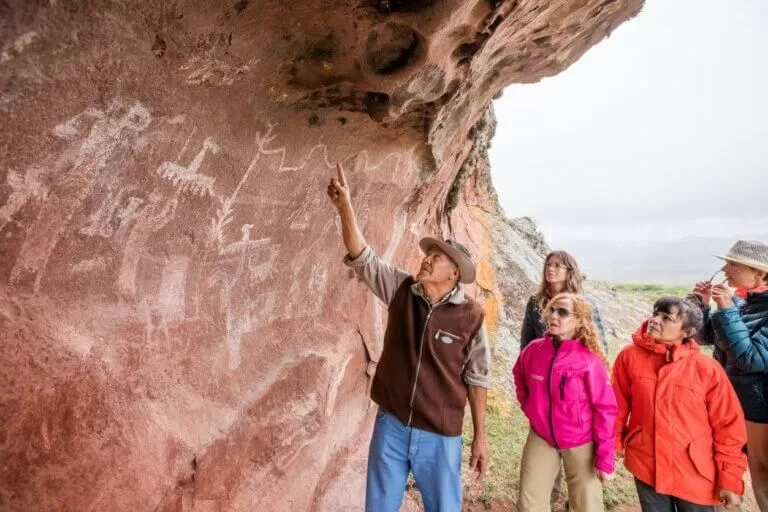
[704,292,768,423]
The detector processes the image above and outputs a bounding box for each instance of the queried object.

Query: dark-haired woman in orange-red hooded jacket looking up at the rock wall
[613,297,747,512]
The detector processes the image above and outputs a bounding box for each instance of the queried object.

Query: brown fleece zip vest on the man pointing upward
[371,277,484,436]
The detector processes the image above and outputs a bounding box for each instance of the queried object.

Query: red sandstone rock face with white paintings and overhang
[0,0,641,512]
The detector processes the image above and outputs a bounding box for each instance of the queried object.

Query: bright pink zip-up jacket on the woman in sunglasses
[512,337,617,473]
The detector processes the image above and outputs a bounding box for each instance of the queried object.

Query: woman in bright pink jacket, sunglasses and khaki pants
[513,293,617,512]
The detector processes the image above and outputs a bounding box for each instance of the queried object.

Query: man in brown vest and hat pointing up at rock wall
[328,165,490,512]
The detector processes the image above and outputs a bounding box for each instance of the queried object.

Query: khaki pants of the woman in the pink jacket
[518,431,604,512]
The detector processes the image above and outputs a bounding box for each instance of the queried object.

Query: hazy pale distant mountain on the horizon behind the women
[553,234,768,286]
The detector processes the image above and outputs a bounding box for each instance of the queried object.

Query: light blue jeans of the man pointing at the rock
[365,409,461,512]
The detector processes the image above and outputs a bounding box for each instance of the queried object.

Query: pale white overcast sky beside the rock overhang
[490,0,768,244]
